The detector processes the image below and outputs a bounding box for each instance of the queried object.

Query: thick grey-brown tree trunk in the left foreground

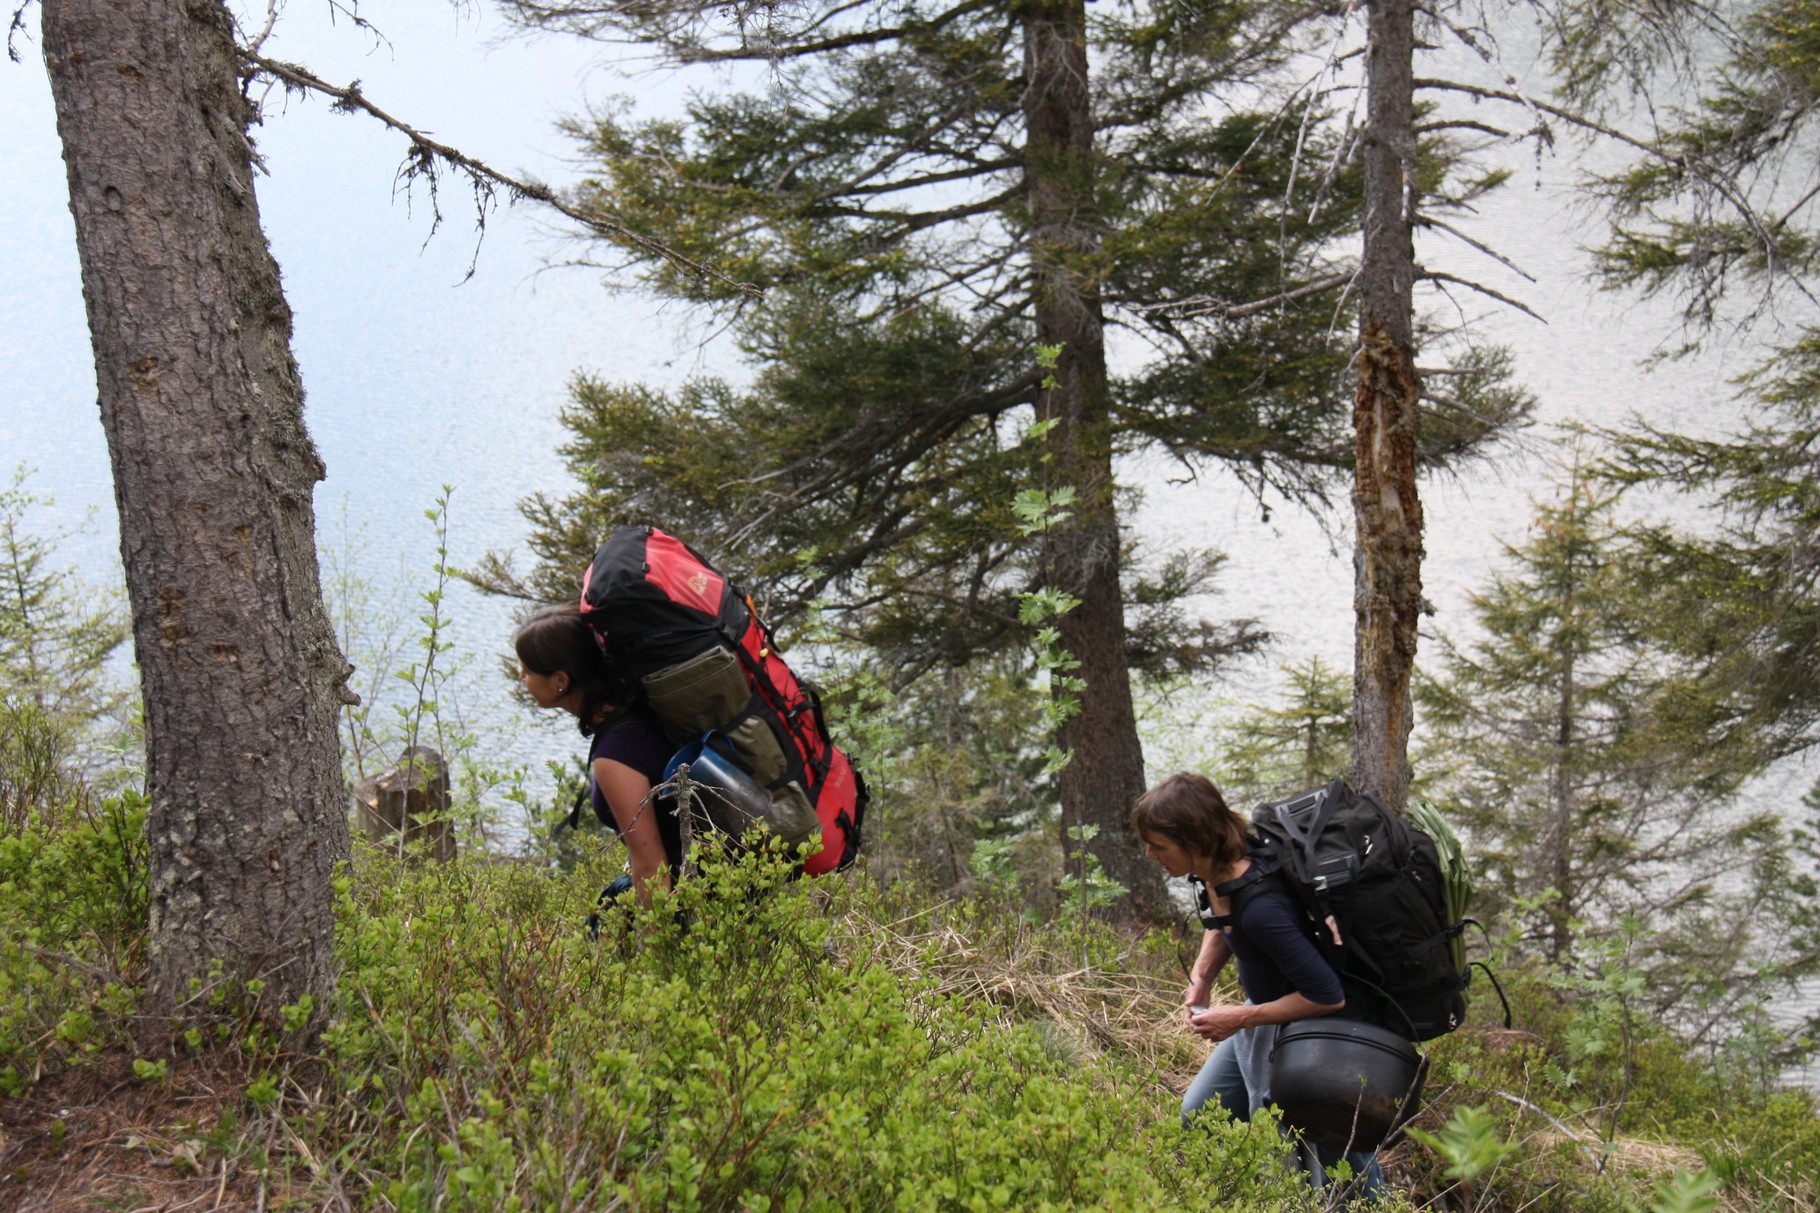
[44,0,348,1018]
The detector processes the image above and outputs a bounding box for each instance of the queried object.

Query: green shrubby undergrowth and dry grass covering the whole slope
[0,801,1820,1213]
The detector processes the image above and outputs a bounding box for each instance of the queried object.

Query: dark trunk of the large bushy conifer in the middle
[1021,0,1168,922]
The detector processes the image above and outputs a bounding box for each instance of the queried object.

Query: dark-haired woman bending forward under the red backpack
[513,607,683,905]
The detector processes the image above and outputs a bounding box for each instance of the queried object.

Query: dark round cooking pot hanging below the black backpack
[1270,1018,1429,1151]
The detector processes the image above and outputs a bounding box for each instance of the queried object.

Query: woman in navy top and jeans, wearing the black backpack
[1132,772,1385,1200]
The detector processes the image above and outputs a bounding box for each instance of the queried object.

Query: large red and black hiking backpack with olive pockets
[581,526,868,876]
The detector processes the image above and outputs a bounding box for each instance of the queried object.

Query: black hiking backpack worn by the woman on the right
[1214,780,1472,1040]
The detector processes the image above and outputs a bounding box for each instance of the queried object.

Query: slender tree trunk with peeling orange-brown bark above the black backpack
[1352,0,1423,809]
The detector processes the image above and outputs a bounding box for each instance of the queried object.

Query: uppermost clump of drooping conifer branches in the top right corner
[1551,0,1820,331]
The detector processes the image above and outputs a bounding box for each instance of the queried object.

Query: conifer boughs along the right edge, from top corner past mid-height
[1554,0,1820,801]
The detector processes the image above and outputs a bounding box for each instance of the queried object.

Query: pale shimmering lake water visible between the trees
[0,0,1820,1078]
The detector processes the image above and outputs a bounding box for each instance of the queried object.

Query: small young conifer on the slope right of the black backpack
[1421,460,1820,1029]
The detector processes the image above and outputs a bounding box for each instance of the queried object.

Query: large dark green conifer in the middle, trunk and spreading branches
[490,0,1527,912]
